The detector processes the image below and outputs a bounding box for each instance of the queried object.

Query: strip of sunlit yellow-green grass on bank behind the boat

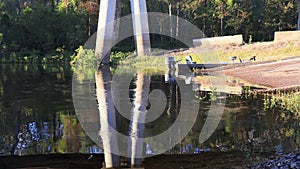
[163,42,300,63]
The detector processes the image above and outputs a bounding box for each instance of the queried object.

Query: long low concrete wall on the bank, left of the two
[193,35,243,47]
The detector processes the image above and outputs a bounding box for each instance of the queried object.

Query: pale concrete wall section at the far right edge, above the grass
[274,31,300,43]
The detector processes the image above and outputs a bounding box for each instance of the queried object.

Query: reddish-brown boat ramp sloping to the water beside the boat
[224,56,300,89]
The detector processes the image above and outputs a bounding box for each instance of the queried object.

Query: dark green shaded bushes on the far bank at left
[0,1,88,63]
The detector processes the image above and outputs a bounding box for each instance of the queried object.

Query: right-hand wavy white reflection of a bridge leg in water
[128,72,150,167]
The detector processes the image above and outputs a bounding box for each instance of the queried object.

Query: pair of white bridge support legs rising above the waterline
[95,0,150,64]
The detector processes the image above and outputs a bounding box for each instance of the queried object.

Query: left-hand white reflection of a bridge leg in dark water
[95,66,120,168]
